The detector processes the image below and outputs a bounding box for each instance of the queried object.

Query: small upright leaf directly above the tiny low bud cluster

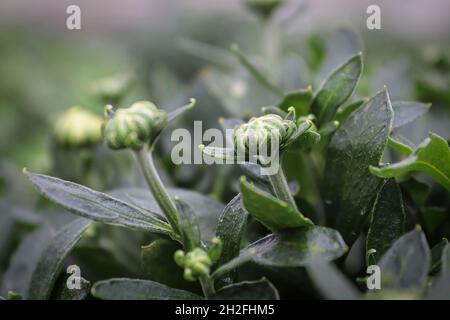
[174,196,200,251]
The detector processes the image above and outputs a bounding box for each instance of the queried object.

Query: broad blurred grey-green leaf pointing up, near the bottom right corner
[378,227,431,291]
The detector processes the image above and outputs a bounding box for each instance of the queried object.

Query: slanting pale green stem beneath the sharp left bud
[134,148,179,234]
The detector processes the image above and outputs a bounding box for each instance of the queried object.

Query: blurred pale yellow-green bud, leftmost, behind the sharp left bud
[53,106,102,148]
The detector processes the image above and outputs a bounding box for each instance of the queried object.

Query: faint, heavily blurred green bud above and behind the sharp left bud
[91,74,132,104]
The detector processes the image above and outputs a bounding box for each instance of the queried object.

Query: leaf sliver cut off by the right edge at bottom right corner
[427,243,450,300]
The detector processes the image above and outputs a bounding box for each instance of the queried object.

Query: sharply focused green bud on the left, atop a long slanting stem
[102,101,167,150]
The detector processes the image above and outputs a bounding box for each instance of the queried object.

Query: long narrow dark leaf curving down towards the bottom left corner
[26,218,91,300]
